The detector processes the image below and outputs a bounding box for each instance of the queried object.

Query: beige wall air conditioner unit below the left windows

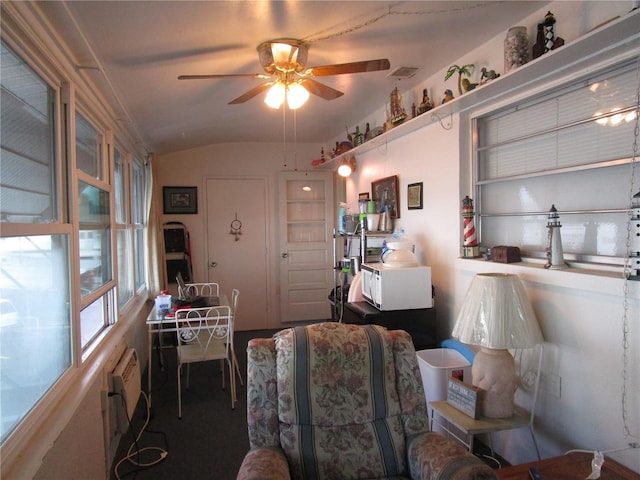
[112,348,141,432]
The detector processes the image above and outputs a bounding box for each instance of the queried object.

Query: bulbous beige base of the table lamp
[471,347,517,418]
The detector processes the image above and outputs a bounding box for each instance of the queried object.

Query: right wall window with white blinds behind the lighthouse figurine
[474,62,639,265]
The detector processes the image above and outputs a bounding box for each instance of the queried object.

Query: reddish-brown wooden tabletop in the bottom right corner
[495,452,640,480]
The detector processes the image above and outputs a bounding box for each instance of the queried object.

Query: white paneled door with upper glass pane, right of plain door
[278,172,333,322]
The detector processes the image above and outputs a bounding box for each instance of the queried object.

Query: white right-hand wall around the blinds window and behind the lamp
[340,2,640,472]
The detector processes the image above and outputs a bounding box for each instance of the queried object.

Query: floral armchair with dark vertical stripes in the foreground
[237,323,496,480]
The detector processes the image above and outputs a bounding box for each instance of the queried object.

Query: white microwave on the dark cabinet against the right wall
[361,263,433,310]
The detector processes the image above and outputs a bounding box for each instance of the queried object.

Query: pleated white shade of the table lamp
[452,273,544,349]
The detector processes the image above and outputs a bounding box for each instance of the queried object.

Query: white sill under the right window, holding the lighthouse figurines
[456,258,640,299]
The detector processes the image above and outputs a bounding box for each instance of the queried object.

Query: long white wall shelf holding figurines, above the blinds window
[315,9,640,170]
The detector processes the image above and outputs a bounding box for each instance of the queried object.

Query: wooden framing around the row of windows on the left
[0,11,150,468]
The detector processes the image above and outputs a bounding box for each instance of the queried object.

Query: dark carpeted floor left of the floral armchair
[111,330,274,480]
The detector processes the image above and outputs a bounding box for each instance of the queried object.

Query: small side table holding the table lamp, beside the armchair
[429,400,540,458]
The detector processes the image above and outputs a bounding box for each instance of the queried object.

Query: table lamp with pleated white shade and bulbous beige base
[452,273,544,418]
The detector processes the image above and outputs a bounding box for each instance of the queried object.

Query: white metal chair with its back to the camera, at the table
[175,306,237,418]
